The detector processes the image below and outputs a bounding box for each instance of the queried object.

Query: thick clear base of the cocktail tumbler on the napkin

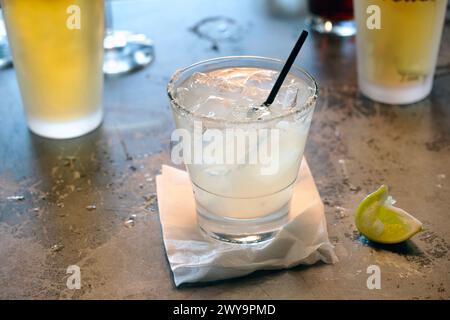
[196,203,289,244]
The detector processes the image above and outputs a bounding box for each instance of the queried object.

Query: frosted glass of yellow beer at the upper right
[353,0,447,104]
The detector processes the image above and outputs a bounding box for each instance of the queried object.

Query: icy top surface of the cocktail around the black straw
[177,68,311,120]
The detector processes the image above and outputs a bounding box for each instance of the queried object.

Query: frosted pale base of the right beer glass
[358,77,433,104]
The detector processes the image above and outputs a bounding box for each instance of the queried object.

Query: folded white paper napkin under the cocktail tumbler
[156,159,337,286]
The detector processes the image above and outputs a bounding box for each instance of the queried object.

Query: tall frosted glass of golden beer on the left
[0,0,104,139]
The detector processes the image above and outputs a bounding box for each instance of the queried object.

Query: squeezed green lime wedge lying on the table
[355,185,422,243]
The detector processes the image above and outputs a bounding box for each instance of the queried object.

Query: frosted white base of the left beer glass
[28,108,103,139]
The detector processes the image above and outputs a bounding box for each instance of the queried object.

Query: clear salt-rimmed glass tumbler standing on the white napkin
[168,57,318,243]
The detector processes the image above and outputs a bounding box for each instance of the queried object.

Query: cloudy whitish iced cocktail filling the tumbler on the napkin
[169,58,317,242]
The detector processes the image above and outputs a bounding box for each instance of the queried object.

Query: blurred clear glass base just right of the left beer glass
[103,31,154,75]
